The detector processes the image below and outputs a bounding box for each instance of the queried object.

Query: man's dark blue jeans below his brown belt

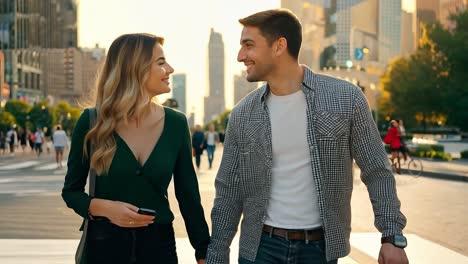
[239,232,338,264]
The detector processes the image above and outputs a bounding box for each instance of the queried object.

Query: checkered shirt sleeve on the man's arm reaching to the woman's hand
[206,112,242,264]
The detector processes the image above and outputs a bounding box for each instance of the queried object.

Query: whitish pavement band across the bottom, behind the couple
[0,233,468,264]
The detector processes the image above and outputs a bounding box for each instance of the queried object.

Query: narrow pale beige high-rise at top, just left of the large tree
[378,0,402,64]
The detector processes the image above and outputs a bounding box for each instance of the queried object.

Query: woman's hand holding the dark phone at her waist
[89,198,154,227]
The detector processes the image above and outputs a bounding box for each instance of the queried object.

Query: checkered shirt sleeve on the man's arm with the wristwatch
[351,89,406,237]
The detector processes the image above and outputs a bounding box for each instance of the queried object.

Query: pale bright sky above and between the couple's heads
[78,0,280,123]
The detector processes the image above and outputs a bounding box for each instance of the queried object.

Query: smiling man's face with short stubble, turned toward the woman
[237,26,275,82]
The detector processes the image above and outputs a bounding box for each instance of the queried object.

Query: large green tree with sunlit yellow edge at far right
[379,10,468,131]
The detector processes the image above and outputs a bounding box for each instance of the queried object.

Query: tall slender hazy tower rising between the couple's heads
[204,29,226,124]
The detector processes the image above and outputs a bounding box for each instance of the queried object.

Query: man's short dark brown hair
[239,8,302,59]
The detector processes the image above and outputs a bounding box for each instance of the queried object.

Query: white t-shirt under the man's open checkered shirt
[265,90,322,229]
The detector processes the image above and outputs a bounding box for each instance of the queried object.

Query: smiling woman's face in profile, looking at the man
[145,43,174,97]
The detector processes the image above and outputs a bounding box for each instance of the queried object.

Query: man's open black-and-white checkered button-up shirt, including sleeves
[206,66,406,264]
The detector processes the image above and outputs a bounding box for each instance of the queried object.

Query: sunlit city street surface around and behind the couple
[0,147,468,264]
